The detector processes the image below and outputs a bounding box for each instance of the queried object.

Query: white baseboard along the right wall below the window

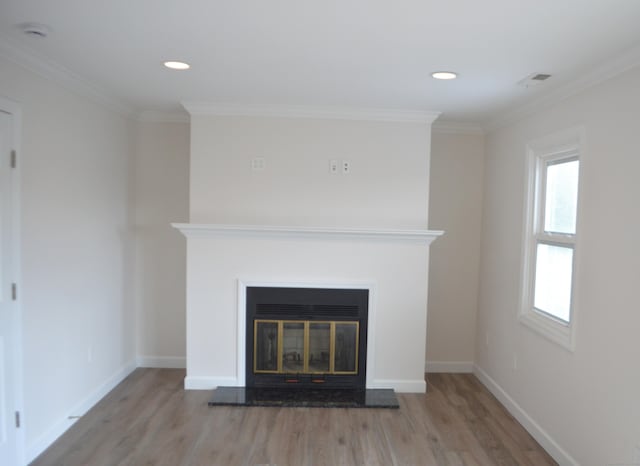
[473,365,580,466]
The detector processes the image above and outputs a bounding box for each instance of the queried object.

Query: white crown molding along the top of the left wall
[0,37,133,117]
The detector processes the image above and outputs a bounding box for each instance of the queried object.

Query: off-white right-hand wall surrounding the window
[476,68,640,466]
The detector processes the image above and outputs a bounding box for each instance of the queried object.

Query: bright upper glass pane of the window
[544,160,579,234]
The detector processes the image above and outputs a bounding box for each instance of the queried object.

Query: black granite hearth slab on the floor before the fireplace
[209,387,400,409]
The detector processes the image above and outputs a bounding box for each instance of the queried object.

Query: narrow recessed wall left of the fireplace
[135,122,189,367]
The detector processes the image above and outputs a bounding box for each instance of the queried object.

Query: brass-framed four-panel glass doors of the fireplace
[253,320,359,375]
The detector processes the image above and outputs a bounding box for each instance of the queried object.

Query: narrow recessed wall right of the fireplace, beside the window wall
[426,128,484,372]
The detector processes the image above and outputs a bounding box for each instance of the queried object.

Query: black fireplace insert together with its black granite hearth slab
[209,286,400,408]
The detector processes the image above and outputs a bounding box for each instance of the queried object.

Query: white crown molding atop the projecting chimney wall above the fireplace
[182,102,440,124]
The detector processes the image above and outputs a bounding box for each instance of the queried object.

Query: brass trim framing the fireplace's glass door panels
[253,319,360,375]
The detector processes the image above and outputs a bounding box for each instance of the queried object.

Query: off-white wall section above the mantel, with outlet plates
[190,116,430,228]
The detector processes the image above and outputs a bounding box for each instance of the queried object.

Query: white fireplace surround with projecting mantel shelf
[174,224,442,393]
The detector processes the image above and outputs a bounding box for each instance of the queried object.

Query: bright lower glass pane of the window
[533,243,573,322]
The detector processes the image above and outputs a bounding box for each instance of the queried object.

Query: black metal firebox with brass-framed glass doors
[246,287,369,389]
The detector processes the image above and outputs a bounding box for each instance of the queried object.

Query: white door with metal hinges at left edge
[0,108,19,465]
